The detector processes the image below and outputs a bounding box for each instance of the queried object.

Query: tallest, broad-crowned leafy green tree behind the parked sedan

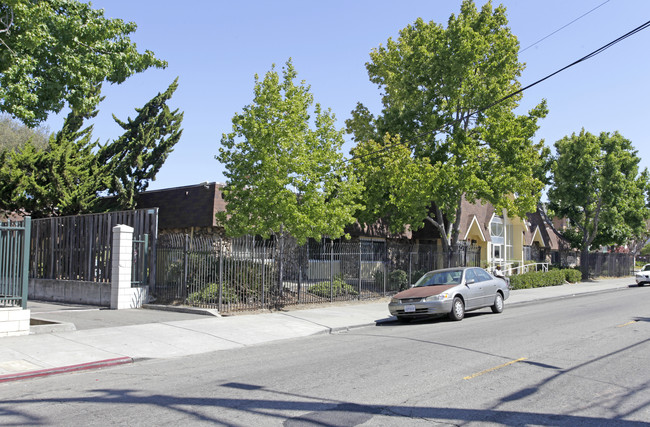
[346,0,547,262]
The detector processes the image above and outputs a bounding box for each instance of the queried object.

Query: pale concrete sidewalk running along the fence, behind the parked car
[0,277,636,382]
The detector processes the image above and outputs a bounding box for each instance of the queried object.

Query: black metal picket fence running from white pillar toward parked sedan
[150,234,480,312]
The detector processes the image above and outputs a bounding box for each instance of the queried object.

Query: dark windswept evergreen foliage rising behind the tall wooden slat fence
[0,81,183,218]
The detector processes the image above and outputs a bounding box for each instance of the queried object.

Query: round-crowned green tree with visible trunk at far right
[548,129,650,279]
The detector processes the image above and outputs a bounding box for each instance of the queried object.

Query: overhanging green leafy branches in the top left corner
[0,0,167,126]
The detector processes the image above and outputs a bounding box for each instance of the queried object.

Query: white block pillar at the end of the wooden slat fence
[111,225,137,310]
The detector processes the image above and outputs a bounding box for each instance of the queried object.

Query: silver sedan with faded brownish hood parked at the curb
[388,267,510,320]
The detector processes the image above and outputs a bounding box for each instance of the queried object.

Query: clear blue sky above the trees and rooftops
[46,0,650,190]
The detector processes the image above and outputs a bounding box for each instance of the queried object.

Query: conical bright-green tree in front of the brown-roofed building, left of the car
[216,60,360,243]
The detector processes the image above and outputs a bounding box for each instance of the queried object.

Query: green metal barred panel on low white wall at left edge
[0,216,32,309]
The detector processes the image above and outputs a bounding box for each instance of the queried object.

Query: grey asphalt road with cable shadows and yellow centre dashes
[0,287,650,426]
